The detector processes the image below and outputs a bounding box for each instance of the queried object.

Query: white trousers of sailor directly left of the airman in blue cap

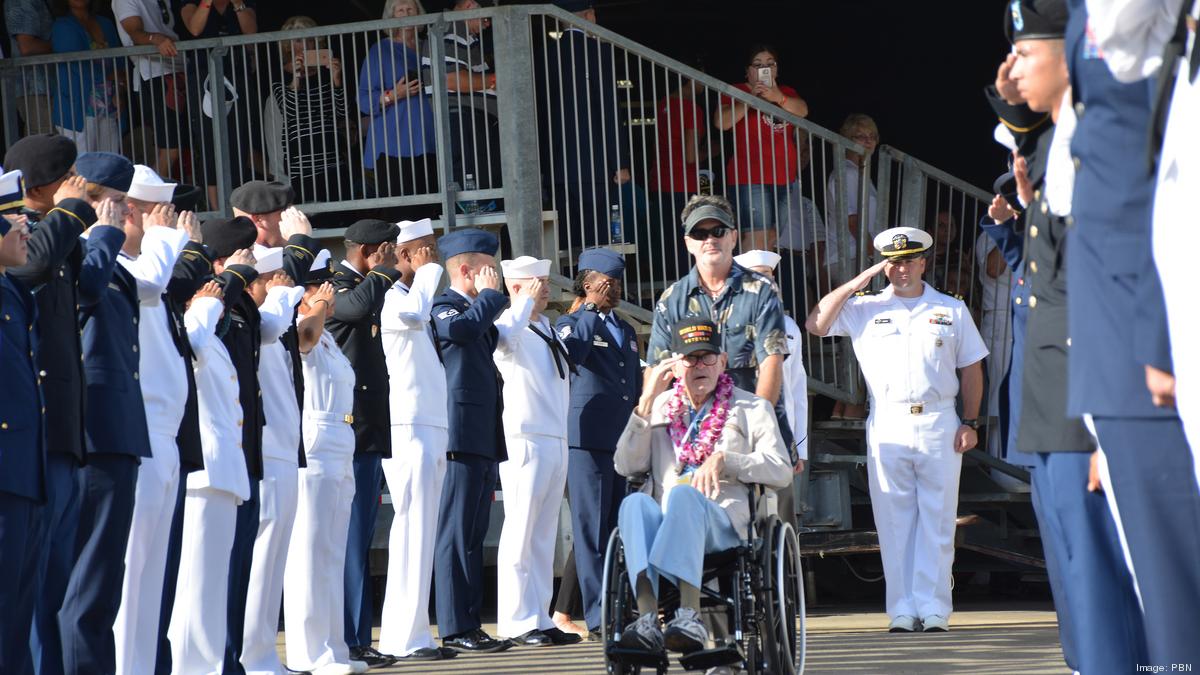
[379,424,450,656]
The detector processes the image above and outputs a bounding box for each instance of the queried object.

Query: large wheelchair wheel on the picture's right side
[767,522,806,675]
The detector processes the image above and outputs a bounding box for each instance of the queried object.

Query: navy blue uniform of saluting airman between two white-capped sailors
[430,283,509,639]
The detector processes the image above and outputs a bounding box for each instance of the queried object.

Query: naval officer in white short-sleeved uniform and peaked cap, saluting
[805,227,988,632]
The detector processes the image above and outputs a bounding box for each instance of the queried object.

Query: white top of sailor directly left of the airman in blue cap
[379,263,450,429]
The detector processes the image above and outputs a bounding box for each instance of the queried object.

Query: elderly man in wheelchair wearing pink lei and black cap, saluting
[604,318,803,673]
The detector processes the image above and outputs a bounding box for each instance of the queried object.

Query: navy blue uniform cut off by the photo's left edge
[0,270,46,673]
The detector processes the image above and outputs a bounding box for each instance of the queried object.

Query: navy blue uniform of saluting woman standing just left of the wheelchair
[556,309,642,628]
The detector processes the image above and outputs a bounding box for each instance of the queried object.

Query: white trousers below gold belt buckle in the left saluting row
[283,437,354,670]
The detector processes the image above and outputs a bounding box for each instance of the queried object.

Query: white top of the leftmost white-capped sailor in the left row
[116,226,190,438]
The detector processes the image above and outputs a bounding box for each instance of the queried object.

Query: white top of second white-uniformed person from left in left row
[184,298,250,500]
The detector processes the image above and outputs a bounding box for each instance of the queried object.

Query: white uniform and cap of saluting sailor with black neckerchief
[493,256,571,638]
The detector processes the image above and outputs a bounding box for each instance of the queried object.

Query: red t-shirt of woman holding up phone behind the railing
[721,82,800,185]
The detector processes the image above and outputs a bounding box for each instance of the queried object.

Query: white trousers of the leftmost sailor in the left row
[113,431,179,675]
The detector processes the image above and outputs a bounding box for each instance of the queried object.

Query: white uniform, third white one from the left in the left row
[241,271,304,675]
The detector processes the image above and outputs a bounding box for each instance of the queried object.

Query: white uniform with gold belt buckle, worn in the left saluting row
[283,330,354,671]
